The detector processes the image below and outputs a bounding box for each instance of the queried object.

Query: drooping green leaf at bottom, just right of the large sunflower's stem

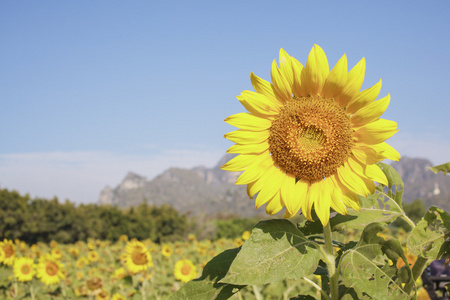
[338,223,412,299]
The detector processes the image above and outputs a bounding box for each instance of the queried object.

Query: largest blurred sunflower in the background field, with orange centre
[124,240,153,274]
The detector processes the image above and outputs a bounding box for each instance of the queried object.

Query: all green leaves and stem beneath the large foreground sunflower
[170,163,450,300]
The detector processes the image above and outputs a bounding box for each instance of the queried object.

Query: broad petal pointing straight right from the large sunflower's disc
[353,119,398,145]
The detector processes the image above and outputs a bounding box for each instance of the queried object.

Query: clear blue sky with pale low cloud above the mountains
[0,1,450,202]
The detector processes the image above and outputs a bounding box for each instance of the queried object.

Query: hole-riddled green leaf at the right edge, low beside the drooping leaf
[408,206,450,261]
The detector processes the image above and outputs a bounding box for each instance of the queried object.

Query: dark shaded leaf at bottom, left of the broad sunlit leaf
[167,248,244,300]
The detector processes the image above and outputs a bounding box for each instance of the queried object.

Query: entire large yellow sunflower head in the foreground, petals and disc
[222,45,400,226]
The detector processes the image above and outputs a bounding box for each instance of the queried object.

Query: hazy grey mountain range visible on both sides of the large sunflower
[99,154,450,217]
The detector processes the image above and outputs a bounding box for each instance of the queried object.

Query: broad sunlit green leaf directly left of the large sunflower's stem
[220,220,320,285]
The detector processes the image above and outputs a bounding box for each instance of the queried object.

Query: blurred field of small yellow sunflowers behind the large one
[0,220,434,300]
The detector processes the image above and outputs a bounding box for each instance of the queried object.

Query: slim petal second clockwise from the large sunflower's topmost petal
[336,57,366,107]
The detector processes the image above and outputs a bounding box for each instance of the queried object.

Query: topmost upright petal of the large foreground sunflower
[301,45,330,96]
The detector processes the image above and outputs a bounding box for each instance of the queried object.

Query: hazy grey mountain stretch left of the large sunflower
[99,155,264,216]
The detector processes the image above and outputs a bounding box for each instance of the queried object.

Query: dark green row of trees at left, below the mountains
[0,189,187,244]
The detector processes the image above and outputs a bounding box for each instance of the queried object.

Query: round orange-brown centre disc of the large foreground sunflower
[268,96,354,182]
